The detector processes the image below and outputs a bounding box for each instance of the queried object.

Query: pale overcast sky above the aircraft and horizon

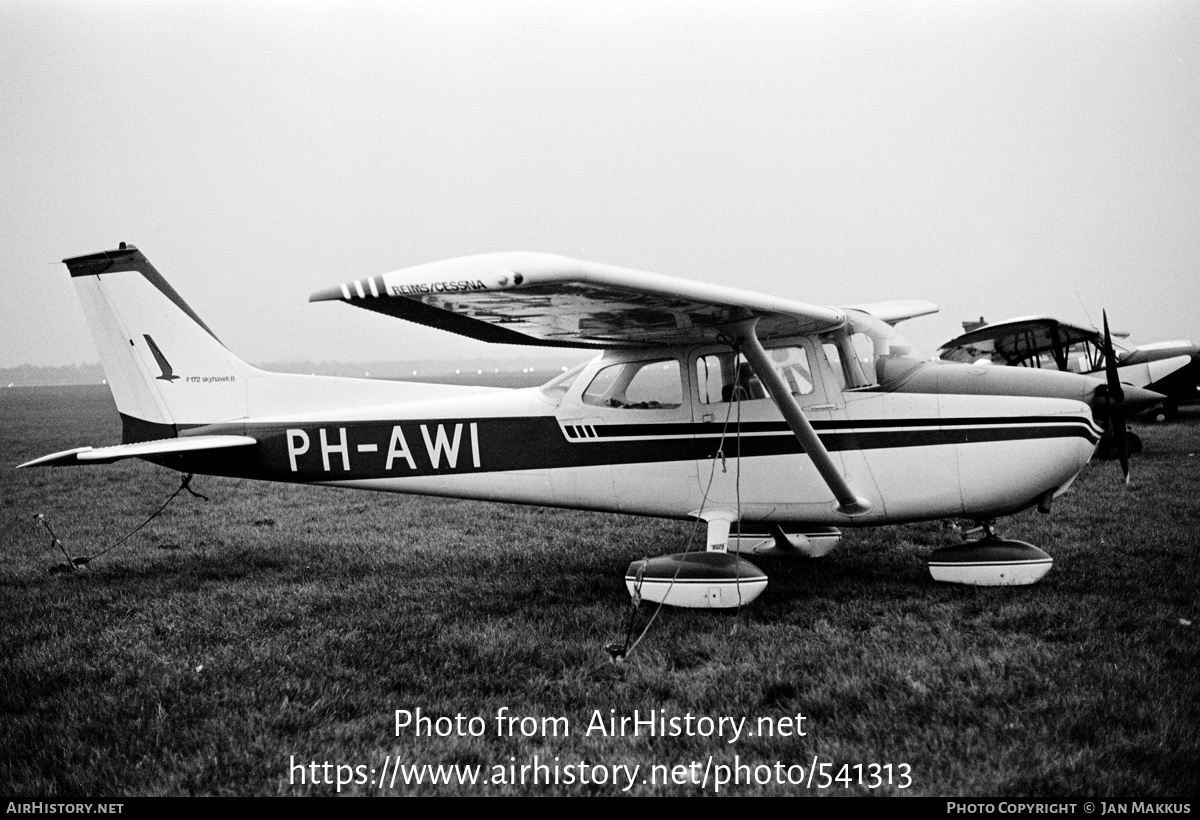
[0,0,1200,366]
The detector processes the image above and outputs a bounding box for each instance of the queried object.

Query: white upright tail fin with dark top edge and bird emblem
[62,243,262,443]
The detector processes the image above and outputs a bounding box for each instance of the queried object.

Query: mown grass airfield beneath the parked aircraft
[0,388,1200,801]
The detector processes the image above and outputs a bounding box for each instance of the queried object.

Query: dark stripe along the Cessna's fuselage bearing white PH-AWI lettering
[169,417,1099,481]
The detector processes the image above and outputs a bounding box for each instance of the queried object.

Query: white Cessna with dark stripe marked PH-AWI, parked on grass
[22,243,1157,606]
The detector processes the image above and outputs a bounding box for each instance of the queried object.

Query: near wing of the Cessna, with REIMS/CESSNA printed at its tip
[308,253,845,348]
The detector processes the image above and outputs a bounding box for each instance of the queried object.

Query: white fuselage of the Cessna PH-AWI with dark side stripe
[171,337,1098,526]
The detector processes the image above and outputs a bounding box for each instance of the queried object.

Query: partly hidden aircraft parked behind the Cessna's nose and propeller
[937,316,1200,420]
